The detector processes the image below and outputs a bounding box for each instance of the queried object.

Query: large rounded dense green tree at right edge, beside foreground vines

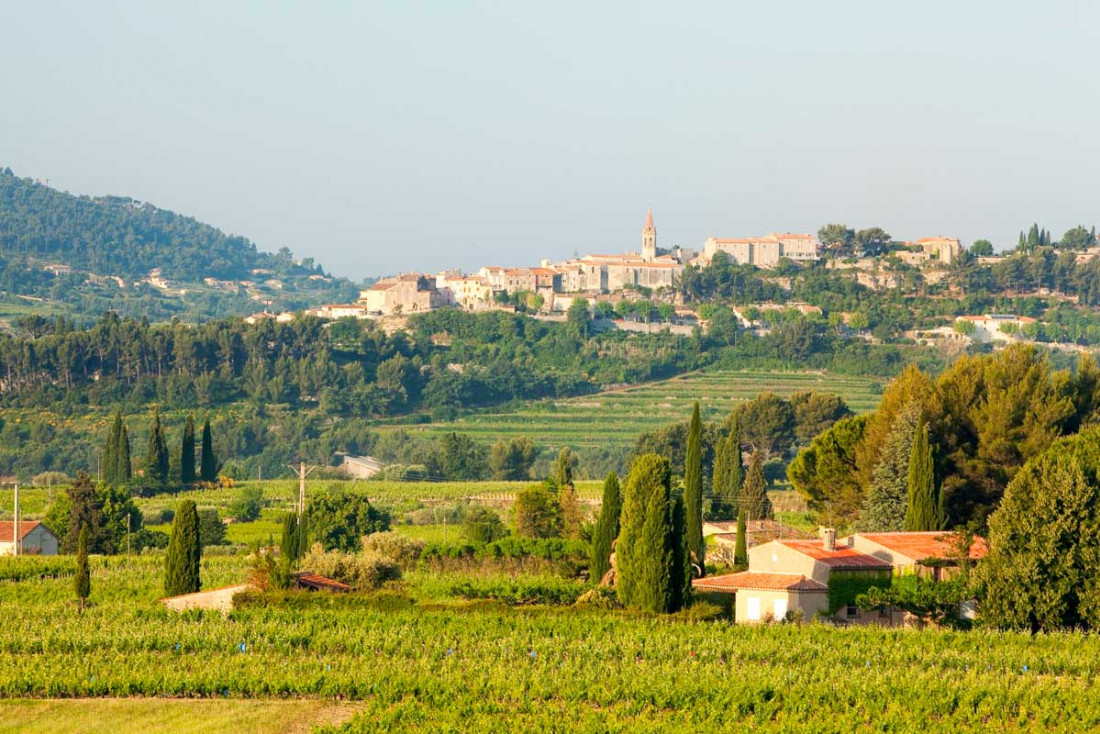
[976,428,1100,632]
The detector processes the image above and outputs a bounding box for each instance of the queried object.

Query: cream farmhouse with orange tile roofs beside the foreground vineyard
[692,528,988,626]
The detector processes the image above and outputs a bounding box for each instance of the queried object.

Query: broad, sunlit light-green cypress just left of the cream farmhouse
[615,453,672,612]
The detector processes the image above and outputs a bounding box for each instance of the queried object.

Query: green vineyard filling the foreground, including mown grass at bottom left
[0,557,1100,734]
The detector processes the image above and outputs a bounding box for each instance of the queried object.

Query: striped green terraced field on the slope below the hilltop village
[382,371,882,448]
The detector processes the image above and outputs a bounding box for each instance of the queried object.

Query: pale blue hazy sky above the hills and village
[0,0,1100,278]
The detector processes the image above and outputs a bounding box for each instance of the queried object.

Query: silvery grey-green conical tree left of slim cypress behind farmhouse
[856,402,921,533]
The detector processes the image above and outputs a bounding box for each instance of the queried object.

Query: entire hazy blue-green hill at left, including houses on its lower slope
[0,168,355,320]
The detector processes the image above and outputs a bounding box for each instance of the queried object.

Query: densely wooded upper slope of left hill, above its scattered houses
[0,168,305,280]
